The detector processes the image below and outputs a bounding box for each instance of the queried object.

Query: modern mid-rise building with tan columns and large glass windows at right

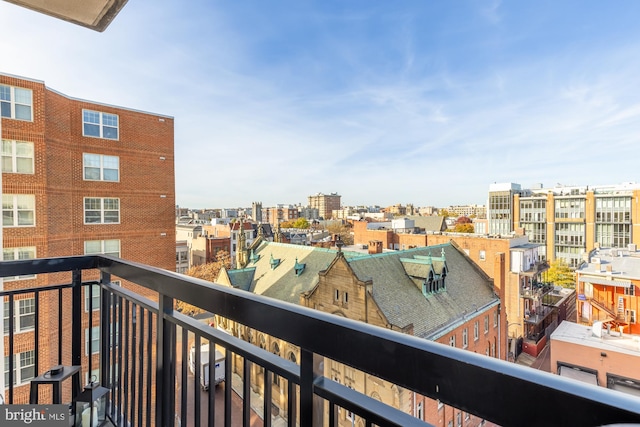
[487,183,640,268]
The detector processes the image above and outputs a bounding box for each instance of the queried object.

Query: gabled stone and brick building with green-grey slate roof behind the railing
[216,239,504,426]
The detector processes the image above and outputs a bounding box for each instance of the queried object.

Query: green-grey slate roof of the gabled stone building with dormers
[229,242,500,339]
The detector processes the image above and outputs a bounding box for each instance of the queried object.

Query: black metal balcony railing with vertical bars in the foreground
[0,256,640,426]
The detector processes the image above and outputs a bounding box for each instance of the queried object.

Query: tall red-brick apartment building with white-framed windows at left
[0,74,176,402]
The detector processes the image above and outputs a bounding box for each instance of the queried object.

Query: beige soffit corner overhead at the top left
[5,0,127,32]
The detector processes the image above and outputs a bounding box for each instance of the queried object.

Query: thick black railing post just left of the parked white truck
[156,294,176,427]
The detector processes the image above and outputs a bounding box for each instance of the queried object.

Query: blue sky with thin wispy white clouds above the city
[0,0,640,208]
